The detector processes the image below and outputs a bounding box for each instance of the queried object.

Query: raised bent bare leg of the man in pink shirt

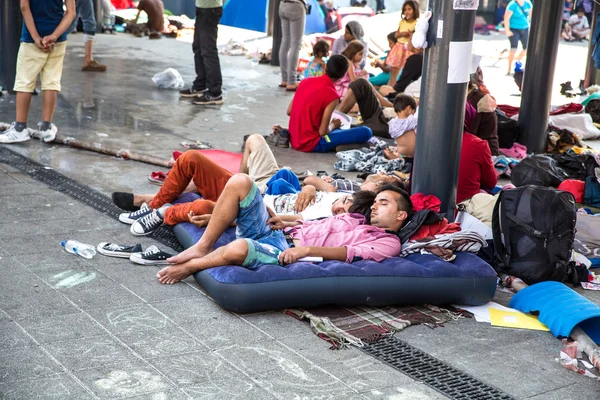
[165,174,253,273]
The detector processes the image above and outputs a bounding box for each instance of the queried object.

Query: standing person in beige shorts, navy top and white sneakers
[0,0,75,143]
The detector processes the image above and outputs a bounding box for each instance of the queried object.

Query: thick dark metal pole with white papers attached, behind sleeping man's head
[412,0,475,218]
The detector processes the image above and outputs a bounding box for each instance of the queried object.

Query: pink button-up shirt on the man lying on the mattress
[291,214,402,263]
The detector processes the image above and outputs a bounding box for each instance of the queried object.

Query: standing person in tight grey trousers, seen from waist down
[279,0,308,92]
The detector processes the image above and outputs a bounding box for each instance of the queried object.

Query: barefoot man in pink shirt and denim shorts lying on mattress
[156,174,413,284]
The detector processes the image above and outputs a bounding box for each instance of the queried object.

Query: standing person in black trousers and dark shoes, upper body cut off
[179,0,224,105]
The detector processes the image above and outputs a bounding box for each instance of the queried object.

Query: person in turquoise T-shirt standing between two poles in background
[504,0,533,75]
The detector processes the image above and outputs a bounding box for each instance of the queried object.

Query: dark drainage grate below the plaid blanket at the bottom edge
[362,336,514,400]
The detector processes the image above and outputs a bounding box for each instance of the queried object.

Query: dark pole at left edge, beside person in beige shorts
[0,1,23,94]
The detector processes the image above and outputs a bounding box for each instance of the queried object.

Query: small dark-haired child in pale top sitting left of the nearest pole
[384,94,417,160]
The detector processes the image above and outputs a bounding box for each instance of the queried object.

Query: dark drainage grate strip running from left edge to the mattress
[0,147,183,252]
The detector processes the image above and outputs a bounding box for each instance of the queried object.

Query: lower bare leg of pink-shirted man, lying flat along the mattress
[156,239,248,285]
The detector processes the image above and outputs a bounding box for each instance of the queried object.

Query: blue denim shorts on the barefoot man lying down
[235,183,289,269]
